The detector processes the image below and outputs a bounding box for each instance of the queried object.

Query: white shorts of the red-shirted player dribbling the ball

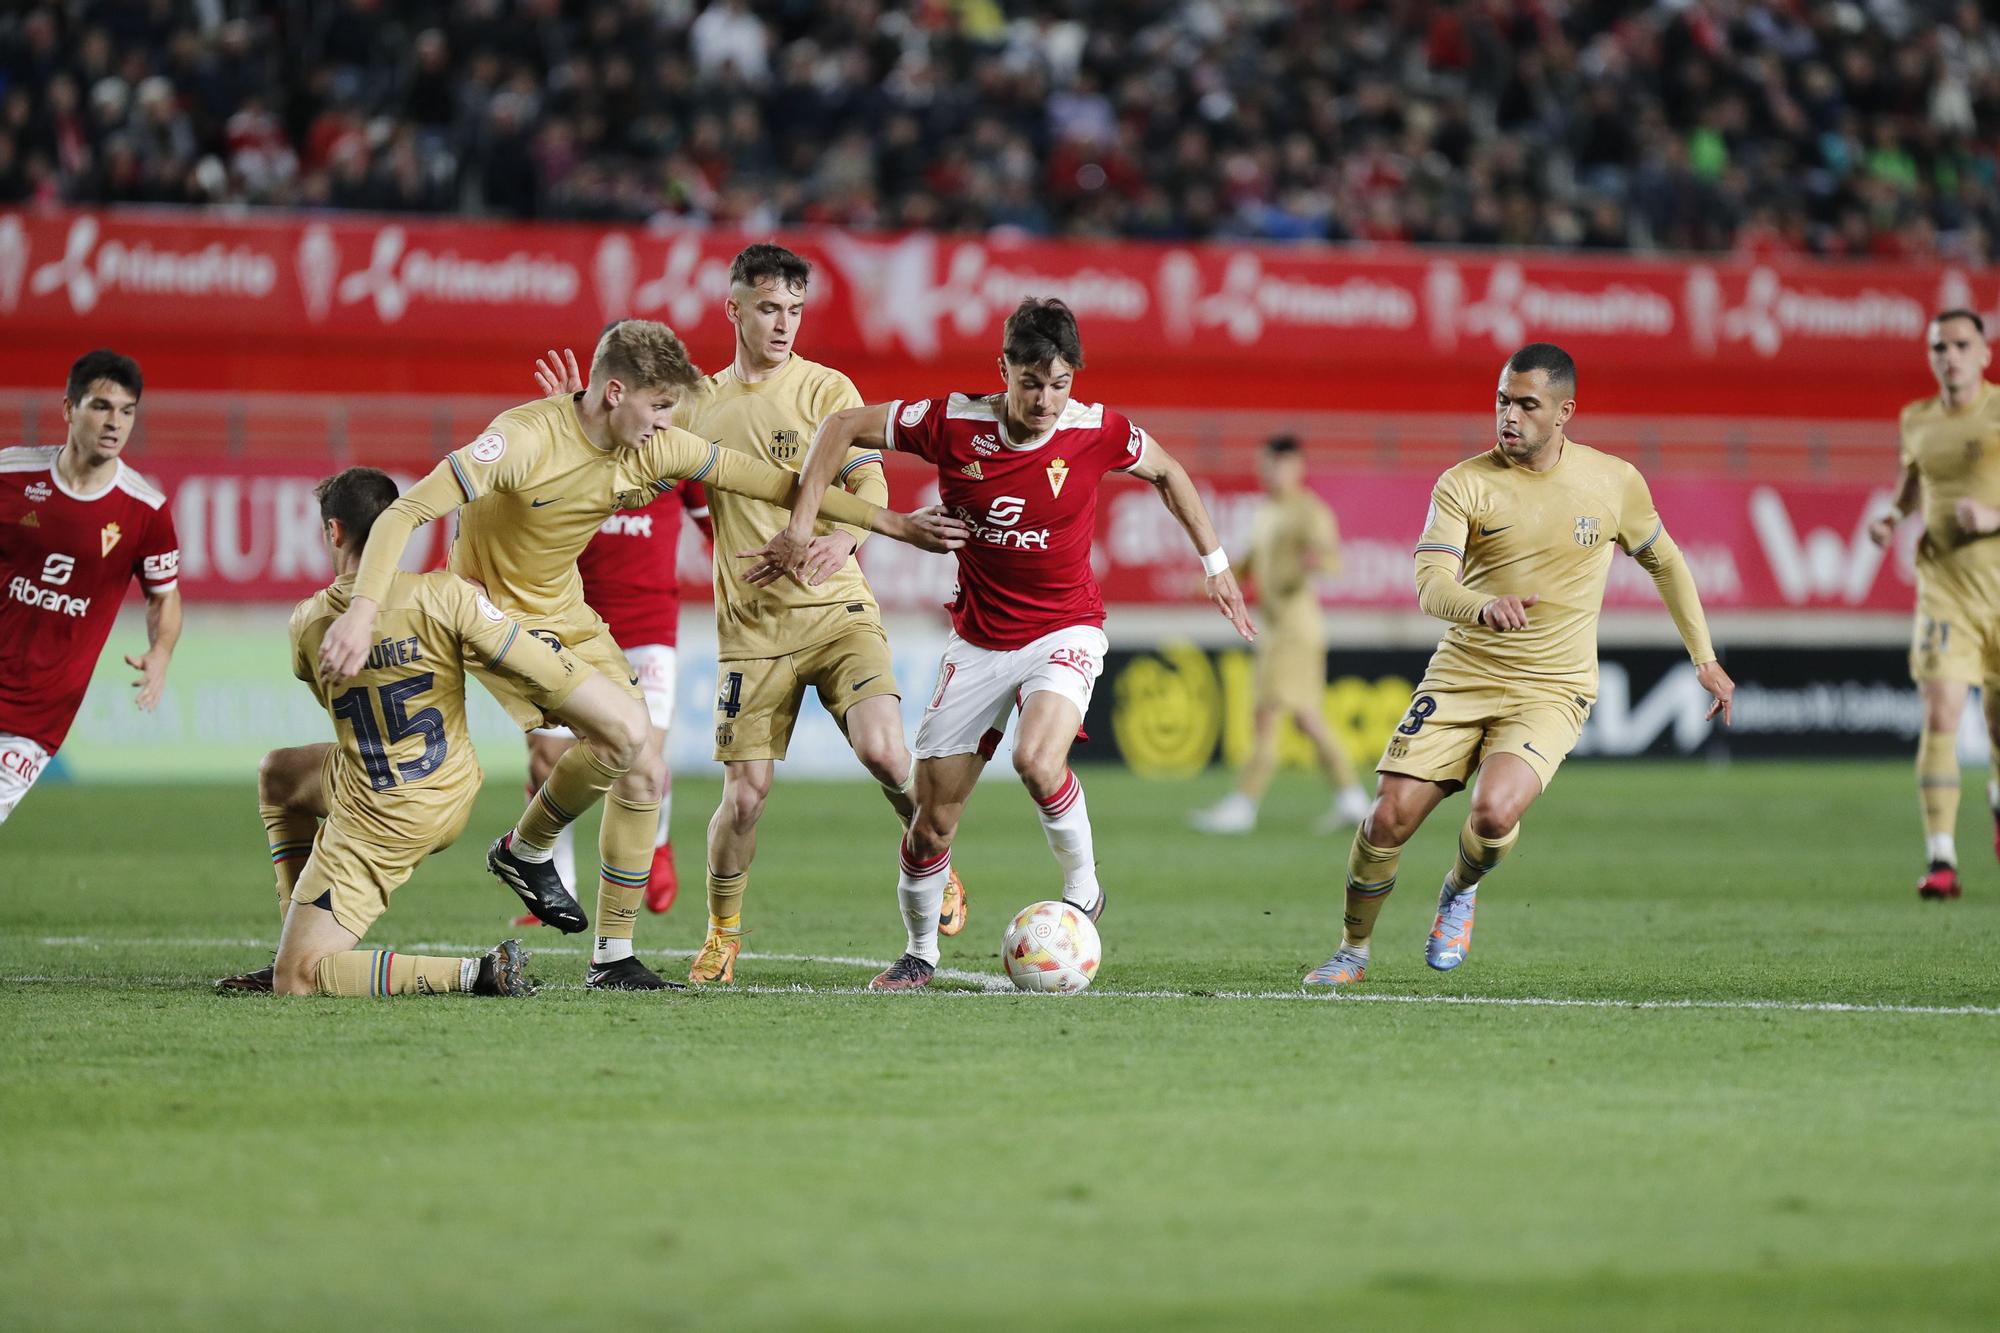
[916,624,1110,759]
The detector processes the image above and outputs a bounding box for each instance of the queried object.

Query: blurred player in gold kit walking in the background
[1190,434,1368,833]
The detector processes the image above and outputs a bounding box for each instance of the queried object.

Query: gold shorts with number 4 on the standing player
[716,626,902,763]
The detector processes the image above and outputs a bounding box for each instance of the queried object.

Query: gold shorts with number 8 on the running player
[1376,677,1590,791]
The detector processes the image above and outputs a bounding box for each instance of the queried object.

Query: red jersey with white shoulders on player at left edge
[0,444,180,755]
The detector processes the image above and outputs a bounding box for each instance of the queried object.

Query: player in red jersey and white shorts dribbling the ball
[750,298,1256,991]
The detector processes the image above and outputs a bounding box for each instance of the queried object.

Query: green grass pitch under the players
[0,763,2000,1331]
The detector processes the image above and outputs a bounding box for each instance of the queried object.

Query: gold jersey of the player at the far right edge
[1902,384,2000,572]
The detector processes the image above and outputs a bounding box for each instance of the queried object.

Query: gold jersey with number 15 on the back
[292,570,584,843]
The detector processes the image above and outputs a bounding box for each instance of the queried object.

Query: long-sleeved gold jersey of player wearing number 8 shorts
[1416,440,1714,701]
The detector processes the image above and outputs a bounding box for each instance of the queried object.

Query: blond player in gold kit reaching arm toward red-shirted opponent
[320,320,962,991]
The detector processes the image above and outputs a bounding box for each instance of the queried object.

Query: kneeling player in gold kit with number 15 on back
[216,468,630,997]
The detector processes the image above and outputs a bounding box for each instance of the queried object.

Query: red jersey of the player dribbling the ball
[888,394,1146,648]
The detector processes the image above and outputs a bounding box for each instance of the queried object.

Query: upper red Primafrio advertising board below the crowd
[0,210,2000,418]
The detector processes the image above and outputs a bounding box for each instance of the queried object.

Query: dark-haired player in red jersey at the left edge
[0,348,180,823]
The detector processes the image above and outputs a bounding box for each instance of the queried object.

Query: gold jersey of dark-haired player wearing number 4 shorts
[684,356,888,662]
